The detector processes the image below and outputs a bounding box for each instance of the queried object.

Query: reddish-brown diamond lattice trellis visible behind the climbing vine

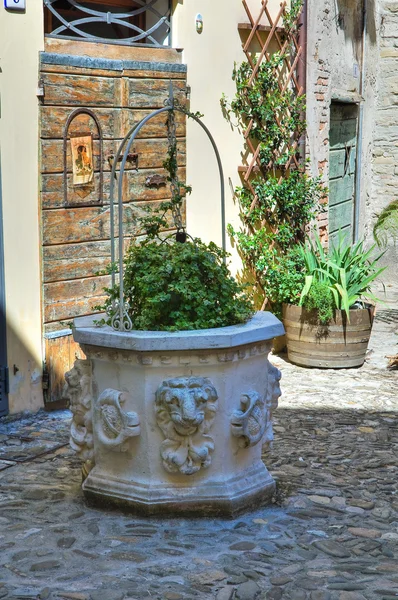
[238,0,305,310]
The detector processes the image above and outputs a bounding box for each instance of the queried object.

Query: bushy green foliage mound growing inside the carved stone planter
[102,237,253,331]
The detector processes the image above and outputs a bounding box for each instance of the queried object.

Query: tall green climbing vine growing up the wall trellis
[221,0,325,312]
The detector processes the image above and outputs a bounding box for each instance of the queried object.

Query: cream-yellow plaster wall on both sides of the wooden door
[0,0,280,412]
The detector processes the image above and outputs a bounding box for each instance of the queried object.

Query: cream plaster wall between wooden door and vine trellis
[173,0,282,271]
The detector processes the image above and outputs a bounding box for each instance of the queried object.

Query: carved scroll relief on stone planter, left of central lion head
[95,389,141,452]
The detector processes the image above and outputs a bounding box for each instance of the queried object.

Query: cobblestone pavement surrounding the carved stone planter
[0,292,398,600]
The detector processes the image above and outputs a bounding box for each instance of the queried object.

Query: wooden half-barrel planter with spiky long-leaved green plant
[283,235,385,368]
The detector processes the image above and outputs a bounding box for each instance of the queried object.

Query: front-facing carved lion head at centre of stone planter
[155,377,218,475]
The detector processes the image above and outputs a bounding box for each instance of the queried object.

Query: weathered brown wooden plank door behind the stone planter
[40,43,186,409]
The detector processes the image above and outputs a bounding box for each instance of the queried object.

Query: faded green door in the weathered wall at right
[329,102,358,245]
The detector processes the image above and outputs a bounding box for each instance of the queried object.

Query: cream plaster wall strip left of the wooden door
[0,0,43,413]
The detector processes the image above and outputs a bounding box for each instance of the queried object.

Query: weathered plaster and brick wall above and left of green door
[307,0,363,242]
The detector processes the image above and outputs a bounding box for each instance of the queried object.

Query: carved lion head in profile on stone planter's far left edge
[64,359,94,471]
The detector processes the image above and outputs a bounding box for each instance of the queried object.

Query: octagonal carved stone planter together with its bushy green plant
[66,103,284,516]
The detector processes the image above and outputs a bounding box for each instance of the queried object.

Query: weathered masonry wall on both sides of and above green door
[307,0,398,283]
